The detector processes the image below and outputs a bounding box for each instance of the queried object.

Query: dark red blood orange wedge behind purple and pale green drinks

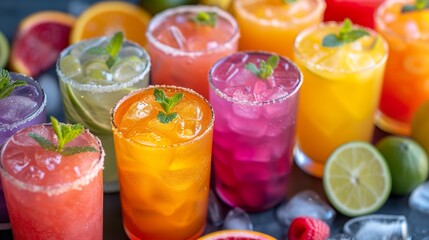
[10,11,75,77]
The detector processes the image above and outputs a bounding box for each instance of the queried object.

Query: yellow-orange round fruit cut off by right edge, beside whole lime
[411,100,429,155]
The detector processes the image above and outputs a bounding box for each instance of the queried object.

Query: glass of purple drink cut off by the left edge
[0,73,46,223]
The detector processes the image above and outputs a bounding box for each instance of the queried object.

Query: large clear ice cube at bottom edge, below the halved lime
[343,214,408,240]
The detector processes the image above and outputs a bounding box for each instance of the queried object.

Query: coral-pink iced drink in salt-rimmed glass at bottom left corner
[0,125,104,240]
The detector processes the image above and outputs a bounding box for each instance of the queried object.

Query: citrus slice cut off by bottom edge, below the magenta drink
[198,230,275,240]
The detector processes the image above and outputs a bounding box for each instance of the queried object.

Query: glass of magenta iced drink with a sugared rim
[209,52,302,211]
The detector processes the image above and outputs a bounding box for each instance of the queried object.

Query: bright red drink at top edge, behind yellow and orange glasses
[324,0,384,28]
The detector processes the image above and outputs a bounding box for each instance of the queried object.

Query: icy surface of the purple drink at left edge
[0,95,37,123]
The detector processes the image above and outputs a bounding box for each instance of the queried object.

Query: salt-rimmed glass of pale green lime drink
[57,37,151,192]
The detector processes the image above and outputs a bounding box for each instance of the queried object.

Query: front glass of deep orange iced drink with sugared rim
[111,86,214,239]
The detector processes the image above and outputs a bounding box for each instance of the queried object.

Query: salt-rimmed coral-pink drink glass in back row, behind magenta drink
[146,5,240,98]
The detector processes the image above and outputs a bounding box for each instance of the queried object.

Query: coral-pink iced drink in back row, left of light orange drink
[147,6,239,98]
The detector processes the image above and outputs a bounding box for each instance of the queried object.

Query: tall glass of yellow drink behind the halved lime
[294,22,388,177]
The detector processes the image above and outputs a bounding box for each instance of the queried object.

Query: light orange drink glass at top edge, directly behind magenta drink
[233,0,326,58]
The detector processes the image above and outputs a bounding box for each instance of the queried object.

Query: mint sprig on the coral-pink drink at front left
[28,116,97,156]
